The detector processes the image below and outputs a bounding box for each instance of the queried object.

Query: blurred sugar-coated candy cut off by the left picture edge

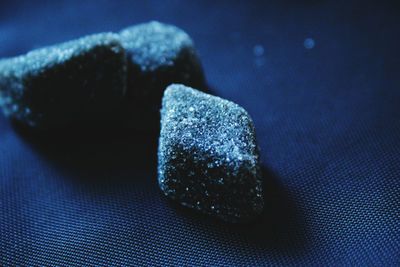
[0,33,127,129]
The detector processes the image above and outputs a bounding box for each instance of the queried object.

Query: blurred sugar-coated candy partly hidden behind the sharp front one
[120,21,204,129]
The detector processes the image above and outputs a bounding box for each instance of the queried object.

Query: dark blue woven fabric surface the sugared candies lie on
[0,0,400,266]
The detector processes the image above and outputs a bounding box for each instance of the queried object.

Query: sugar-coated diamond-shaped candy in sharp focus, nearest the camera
[158,84,264,223]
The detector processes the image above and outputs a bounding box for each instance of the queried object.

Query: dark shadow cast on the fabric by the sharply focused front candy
[169,167,311,253]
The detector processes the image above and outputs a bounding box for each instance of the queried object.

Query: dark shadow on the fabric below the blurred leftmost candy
[13,122,158,186]
